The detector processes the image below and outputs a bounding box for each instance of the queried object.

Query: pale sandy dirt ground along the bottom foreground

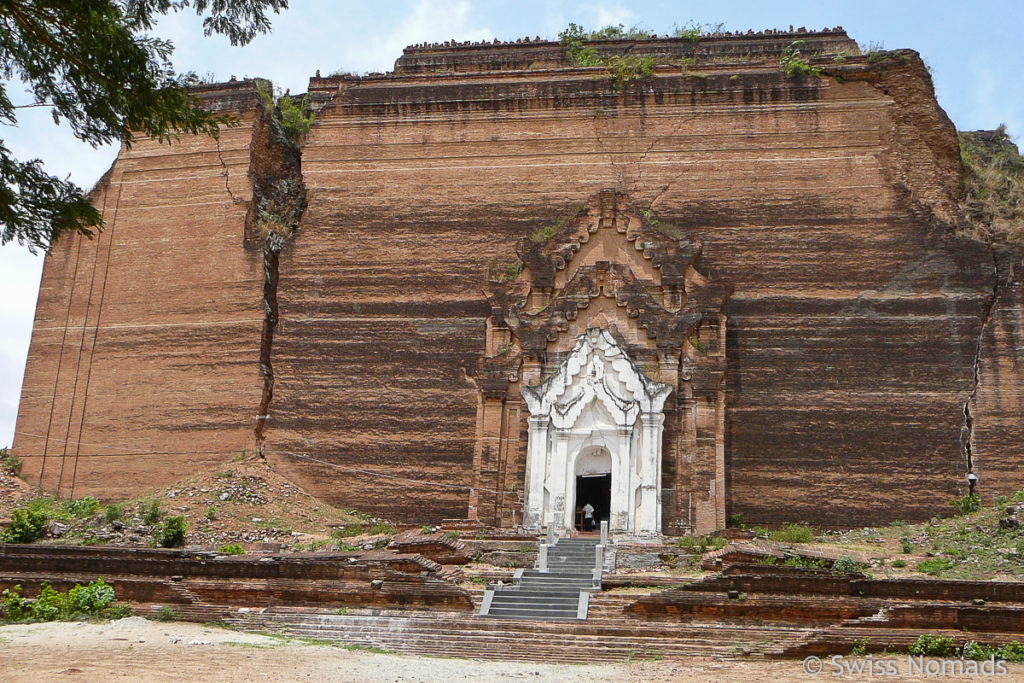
[0,616,1024,683]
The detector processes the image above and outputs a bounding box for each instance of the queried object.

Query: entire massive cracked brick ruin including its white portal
[13,29,1024,535]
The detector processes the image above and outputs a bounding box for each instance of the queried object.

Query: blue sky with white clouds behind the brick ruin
[0,0,1024,446]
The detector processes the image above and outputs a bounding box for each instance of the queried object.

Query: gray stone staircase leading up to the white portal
[480,539,602,621]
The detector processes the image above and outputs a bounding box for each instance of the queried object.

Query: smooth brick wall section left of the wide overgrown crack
[13,82,263,499]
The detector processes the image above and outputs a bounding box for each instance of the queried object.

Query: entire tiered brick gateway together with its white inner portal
[467,189,731,536]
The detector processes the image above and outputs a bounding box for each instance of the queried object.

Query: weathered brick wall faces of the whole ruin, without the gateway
[14,33,1024,526]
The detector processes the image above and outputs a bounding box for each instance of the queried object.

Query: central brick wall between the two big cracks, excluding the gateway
[271,33,994,525]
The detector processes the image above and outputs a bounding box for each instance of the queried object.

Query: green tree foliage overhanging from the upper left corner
[0,0,288,251]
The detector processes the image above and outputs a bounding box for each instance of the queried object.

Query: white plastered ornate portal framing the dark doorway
[522,328,672,536]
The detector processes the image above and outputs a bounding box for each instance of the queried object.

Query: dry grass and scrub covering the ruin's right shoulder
[957,126,1024,243]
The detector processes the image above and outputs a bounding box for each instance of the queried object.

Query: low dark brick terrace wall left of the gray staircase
[0,544,473,613]
